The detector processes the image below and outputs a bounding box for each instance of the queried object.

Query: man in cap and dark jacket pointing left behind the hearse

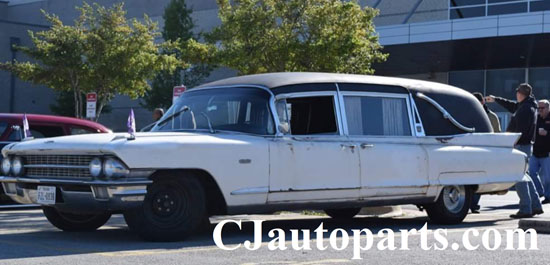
[485,83,544,218]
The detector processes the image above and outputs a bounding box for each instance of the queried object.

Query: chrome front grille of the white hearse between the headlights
[23,155,94,180]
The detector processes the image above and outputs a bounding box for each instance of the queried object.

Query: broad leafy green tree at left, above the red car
[0,3,185,119]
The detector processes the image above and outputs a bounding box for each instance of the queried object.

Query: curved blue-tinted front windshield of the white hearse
[151,87,275,135]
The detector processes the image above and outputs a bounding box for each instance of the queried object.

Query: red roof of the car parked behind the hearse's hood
[0,113,110,132]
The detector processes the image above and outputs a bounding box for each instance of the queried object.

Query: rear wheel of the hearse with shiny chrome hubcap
[424,185,473,224]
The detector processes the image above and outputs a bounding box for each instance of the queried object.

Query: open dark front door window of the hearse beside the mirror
[284,96,338,135]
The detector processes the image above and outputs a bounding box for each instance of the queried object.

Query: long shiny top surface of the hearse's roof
[197,72,469,96]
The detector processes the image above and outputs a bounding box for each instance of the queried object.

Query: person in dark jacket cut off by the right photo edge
[529,99,550,204]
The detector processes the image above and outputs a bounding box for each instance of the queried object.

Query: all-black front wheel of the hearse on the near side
[124,176,206,241]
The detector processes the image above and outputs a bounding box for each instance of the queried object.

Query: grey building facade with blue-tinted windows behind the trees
[0,0,550,130]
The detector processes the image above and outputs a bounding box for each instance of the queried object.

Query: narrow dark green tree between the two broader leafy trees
[142,0,213,110]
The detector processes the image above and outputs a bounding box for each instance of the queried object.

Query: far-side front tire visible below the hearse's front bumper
[42,206,111,232]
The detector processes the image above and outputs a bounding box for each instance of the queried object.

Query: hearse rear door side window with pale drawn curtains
[344,96,412,136]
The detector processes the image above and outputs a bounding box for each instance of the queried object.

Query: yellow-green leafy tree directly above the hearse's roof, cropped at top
[207,0,387,74]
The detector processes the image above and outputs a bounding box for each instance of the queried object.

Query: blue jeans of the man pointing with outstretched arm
[515,144,542,214]
